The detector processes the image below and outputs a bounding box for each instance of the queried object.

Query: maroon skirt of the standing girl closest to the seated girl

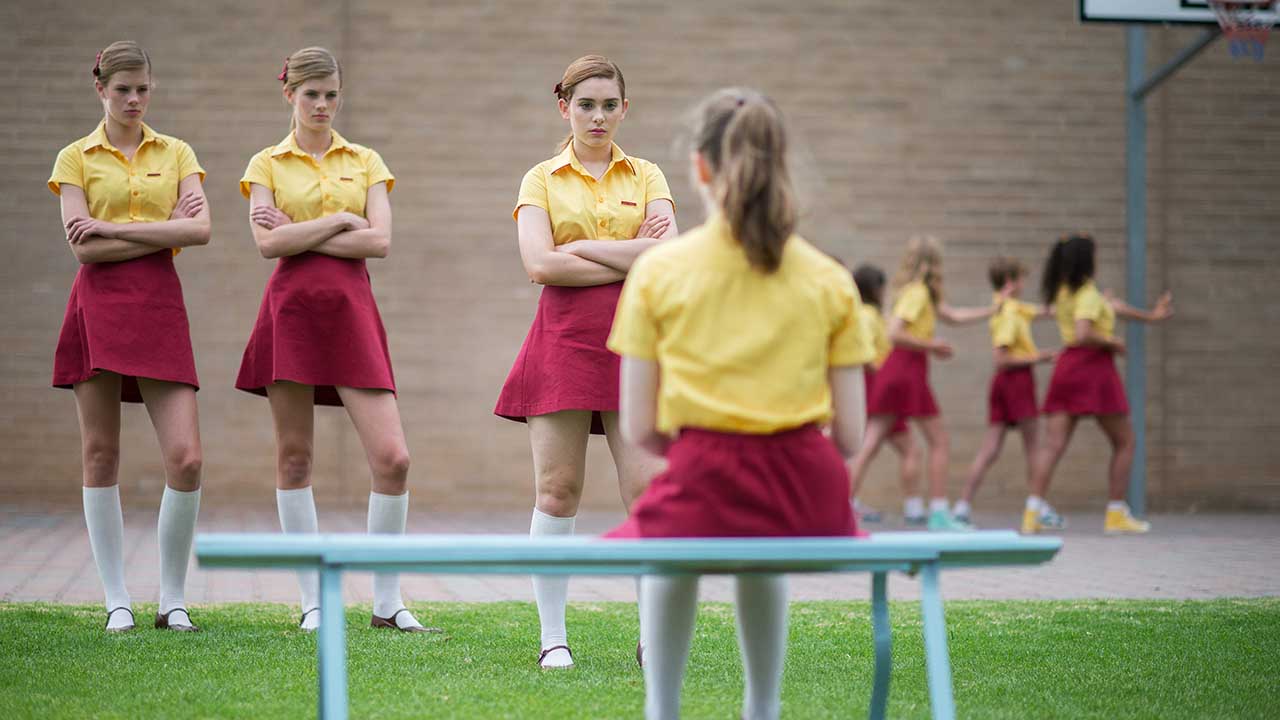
[493,282,622,434]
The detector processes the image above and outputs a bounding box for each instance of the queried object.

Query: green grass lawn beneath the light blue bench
[0,598,1280,719]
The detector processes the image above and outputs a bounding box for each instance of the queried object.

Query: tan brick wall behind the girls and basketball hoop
[0,0,1280,510]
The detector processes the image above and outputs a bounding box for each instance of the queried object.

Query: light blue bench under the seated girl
[196,530,1062,720]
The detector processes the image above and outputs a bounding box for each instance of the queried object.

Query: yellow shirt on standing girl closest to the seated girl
[511,142,675,245]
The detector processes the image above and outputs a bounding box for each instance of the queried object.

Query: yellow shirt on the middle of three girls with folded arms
[241,129,396,223]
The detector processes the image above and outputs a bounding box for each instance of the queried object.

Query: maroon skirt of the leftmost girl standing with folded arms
[52,250,200,402]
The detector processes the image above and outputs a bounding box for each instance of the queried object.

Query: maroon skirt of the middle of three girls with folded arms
[236,252,396,405]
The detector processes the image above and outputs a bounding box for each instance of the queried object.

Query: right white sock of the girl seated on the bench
[737,575,787,720]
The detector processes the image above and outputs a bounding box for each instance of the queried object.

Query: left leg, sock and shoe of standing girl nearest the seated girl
[529,410,591,667]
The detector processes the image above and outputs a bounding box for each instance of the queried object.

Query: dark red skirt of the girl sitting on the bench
[607,425,858,538]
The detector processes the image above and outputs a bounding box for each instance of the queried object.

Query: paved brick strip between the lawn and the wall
[0,505,1280,605]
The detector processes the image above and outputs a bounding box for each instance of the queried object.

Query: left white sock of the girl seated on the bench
[640,575,698,720]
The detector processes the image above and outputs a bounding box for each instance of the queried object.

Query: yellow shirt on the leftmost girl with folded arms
[49,120,205,255]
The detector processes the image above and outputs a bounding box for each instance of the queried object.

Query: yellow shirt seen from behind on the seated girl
[608,215,874,434]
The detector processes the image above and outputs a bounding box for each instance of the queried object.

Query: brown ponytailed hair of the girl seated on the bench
[694,88,797,273]
